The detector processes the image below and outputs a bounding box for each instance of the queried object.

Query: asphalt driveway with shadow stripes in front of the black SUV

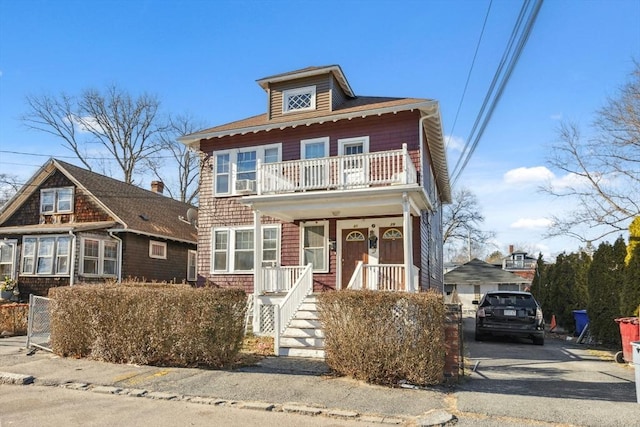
[456,318,640,426]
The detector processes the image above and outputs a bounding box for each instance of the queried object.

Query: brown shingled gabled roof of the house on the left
[0,159,197,243]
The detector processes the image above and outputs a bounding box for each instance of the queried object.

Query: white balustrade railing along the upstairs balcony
[257,144,418,194]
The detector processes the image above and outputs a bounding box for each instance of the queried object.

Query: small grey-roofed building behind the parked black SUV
[444,258,531,313]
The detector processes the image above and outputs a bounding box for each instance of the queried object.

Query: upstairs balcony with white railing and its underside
[241,144,432,222]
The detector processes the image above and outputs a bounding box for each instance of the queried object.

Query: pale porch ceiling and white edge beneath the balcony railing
[241,184,432,222]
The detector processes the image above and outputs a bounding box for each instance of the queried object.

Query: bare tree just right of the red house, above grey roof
[443,188,495,258]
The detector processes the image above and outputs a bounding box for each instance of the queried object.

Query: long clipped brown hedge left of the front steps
[49,284,246,368]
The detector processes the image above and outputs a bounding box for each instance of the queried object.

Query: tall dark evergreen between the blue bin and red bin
[587,237,627,348]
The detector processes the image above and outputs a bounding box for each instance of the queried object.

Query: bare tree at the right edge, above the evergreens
[542,63,640,245]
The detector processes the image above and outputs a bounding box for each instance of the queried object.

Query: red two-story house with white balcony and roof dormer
[180,65,451,354]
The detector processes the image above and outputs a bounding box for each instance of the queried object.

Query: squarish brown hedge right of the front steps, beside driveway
[318,291,445,386]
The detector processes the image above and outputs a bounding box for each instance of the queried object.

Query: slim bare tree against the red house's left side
[146,115,204,204]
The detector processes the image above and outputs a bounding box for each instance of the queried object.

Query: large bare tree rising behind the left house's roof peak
[22,85,166,183]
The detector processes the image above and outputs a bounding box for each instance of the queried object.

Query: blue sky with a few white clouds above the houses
[0,0,640,255]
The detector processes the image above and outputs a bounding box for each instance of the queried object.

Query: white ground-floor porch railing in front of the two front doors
[347,261,415,292]
